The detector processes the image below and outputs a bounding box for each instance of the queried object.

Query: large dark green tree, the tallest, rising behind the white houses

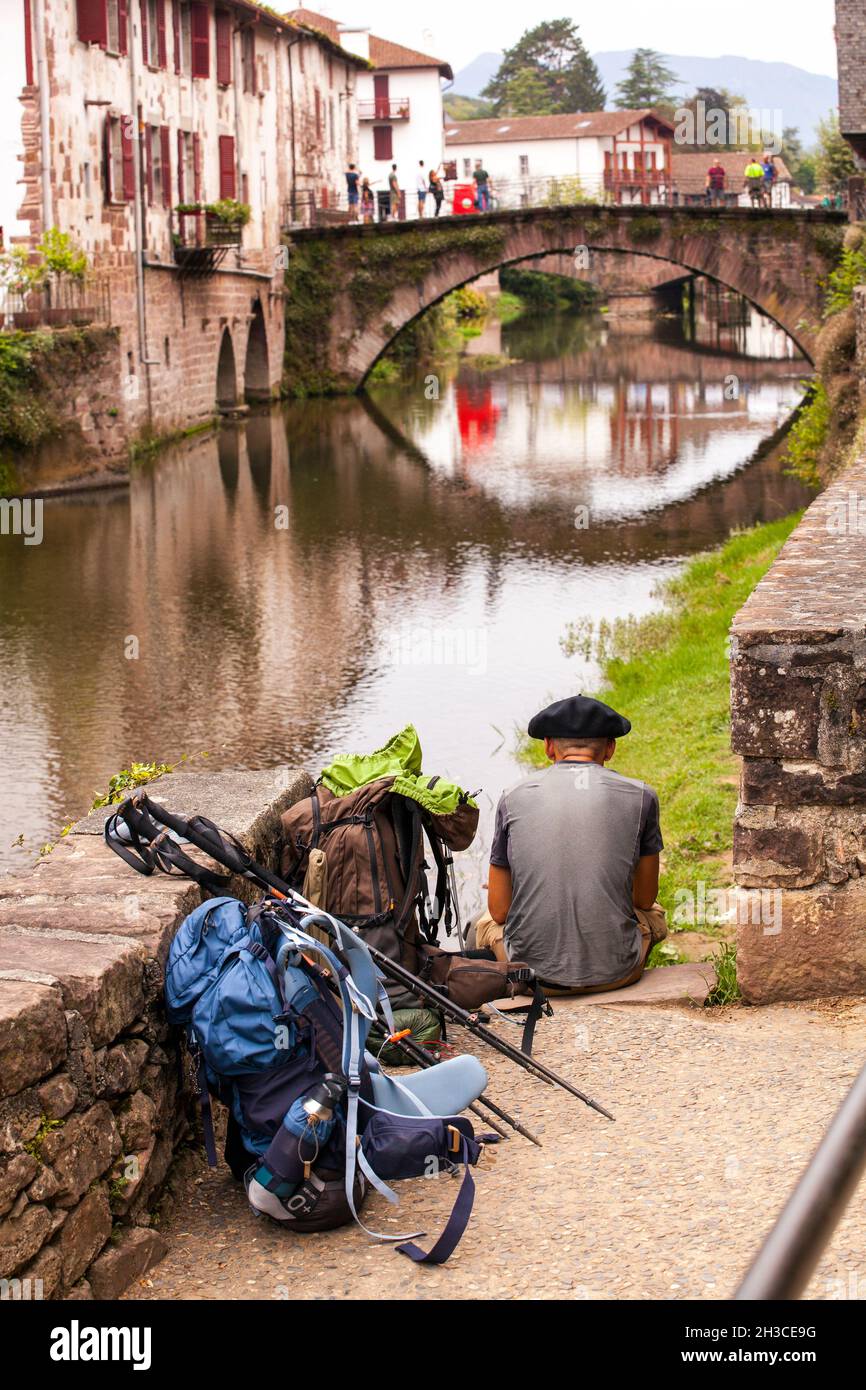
[481,19,606,115]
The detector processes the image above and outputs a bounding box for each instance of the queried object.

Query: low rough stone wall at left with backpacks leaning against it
[0,769,313,1298]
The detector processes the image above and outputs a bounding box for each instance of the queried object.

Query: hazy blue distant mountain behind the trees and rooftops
[452,49,838,145]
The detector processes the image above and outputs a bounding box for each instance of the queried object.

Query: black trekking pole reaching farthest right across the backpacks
[104,791,613,1120]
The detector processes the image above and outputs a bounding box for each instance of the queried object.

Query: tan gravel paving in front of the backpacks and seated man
[125,999,866,1300]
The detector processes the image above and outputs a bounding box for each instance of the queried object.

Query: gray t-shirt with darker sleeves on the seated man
[491,762,662,987]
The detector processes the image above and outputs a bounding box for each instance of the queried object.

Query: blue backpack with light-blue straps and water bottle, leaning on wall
[165,898,495,1264]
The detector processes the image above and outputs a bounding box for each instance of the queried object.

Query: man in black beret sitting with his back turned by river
[475,695,667,994]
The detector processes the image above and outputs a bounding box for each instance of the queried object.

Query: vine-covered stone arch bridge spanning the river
[284,206,847,393]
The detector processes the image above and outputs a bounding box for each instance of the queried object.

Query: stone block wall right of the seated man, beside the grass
[731,459,866,1002]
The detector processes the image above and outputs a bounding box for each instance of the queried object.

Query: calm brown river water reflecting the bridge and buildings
[0,300,808,906]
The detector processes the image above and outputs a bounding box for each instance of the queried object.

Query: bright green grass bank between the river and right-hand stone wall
[523,513,801,945]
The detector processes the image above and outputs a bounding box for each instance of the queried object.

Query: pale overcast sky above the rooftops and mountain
[330,0,839,76]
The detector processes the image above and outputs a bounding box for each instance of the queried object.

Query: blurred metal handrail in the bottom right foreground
[734,1066,866,1302]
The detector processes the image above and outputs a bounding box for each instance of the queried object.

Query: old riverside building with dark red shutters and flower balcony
[19,0,366,438]
